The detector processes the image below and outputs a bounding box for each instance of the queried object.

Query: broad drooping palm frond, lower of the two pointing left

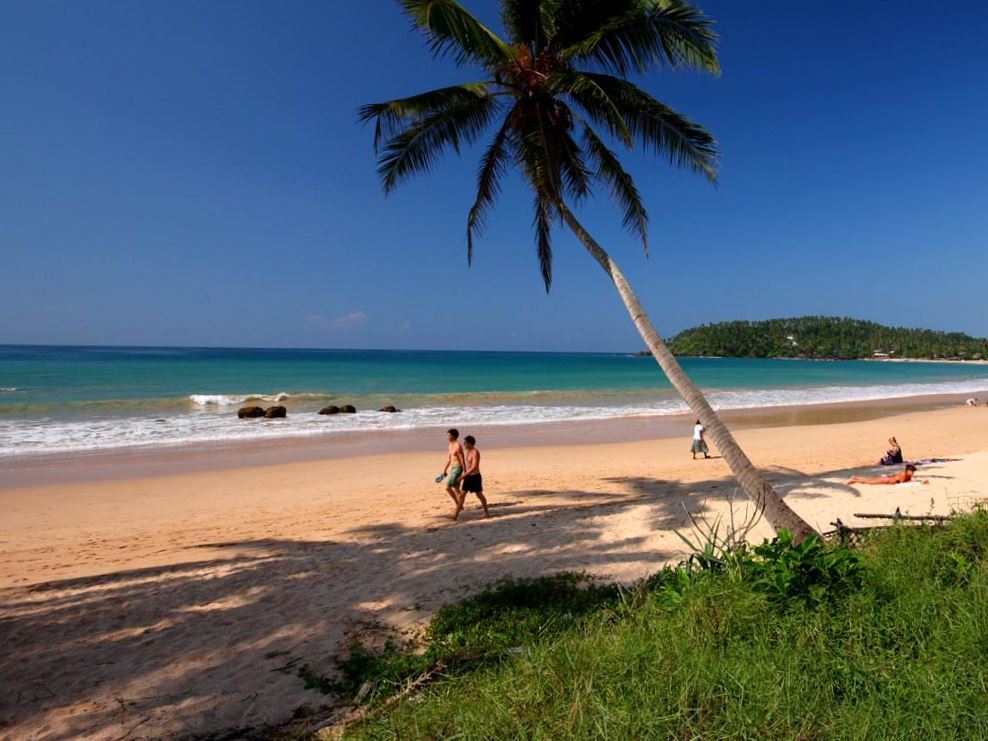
[378,95,500,193]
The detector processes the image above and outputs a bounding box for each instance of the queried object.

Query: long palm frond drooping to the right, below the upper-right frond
[583,72,718,183]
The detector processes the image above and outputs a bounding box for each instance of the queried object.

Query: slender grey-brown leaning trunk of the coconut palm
[558,203,816,542]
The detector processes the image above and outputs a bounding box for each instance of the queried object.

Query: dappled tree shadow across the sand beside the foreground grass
[0,460,956,738]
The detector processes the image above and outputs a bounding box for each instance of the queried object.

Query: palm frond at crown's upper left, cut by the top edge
[400,0,514,67]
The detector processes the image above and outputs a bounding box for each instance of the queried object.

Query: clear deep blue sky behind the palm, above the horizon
[0,0,988,351]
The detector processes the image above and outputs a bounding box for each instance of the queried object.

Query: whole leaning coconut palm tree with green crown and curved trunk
[360,0,814,540]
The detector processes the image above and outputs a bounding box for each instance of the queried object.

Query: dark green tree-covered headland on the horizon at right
[669,316,988,360]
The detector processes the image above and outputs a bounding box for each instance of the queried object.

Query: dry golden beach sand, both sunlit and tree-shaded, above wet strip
[0,408,988,739]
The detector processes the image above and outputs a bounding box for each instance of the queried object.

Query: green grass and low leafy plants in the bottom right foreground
[312,511,988,740]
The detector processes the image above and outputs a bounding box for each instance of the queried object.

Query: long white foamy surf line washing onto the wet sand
[0,379,988,457]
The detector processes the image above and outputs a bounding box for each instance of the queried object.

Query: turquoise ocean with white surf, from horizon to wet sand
[0,346,988,457]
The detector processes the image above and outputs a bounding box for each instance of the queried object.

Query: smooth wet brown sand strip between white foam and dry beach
[0,394,967,491]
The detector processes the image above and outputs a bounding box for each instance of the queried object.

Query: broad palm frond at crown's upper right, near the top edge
[560,0,720,75]
